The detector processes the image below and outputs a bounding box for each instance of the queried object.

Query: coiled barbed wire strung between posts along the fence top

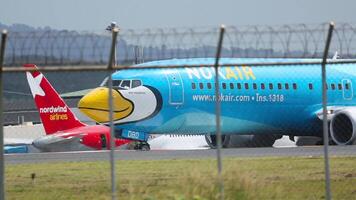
[5,23,356,66]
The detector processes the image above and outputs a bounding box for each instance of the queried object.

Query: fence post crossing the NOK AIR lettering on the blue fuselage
[214,25,225,199]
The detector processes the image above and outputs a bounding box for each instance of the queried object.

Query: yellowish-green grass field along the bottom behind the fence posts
[5,157,356,200]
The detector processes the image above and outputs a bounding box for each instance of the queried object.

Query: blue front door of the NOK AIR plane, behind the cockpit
[166,70,184,105]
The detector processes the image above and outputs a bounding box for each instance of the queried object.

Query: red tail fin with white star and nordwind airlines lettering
[24,64,85,135]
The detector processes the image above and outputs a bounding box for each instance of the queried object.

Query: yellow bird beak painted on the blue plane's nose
[78,87,134,123]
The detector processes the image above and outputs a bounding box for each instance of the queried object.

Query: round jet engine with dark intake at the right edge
[330,108,356,145]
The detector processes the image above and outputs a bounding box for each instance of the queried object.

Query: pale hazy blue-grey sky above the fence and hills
[0,0,356,31]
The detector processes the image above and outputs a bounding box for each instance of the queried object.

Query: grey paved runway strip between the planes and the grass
[5,145,356,164]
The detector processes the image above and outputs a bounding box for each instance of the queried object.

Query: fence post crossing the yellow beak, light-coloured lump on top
[108,27,119,200]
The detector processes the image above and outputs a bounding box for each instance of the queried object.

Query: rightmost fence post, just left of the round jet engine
[321,22,335,200]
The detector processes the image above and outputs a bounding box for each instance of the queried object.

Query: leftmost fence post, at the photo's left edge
[0,30,7,200]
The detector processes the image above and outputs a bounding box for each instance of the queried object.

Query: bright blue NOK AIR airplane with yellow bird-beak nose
[78,58,356,148]
